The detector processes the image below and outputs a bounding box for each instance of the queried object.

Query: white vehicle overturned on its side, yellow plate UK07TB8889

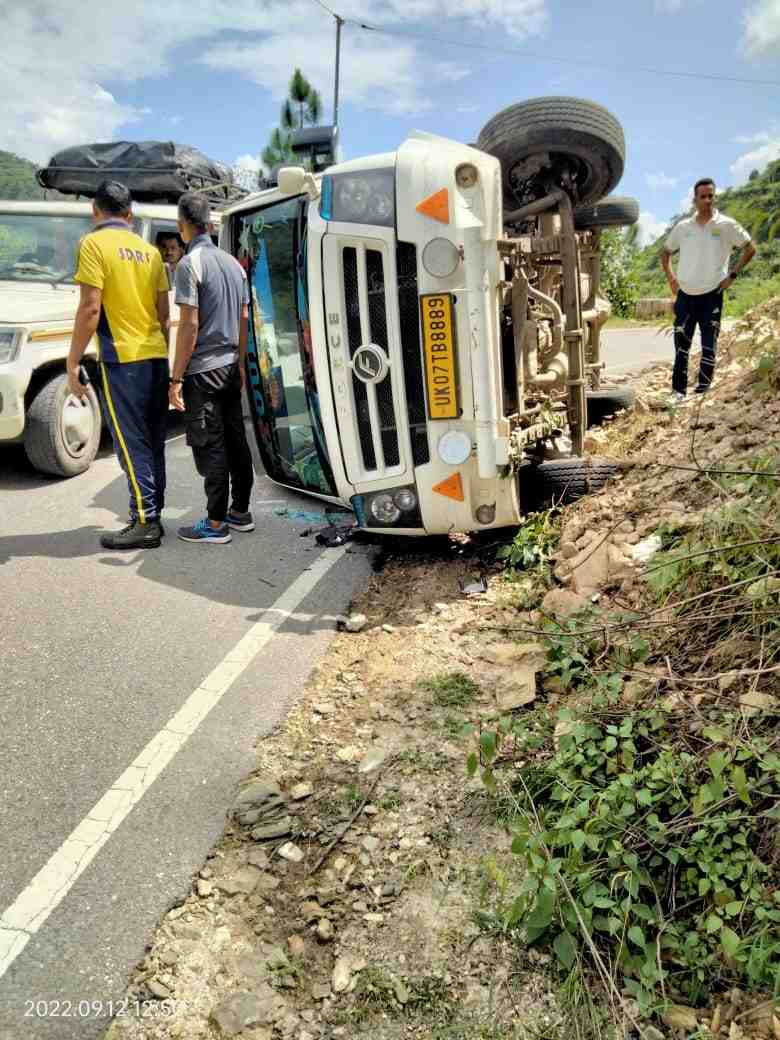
[220,98,638,535]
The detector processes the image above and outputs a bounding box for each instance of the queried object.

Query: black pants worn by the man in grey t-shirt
[182,364,255,523]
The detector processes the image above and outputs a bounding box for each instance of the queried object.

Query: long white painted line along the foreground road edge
[0,547,345,979]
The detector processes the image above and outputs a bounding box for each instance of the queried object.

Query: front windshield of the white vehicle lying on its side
[237,199,336,495]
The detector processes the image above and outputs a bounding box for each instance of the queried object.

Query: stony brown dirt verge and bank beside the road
[110,303,780,1040]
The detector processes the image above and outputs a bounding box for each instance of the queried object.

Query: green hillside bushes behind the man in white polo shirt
[634,159,780,316]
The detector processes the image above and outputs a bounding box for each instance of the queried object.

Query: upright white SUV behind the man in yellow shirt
[0,202,194,476]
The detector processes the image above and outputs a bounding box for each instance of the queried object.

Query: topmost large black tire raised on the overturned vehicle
[477,98,626,210]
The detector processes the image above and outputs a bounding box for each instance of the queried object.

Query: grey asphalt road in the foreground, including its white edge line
[0,420,370,1040]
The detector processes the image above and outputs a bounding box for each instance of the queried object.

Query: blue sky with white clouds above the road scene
[6,0,780,241]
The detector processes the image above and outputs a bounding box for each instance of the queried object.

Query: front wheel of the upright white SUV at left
[24,373,101,476]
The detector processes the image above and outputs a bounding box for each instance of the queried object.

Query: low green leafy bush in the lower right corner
[480,708,780,1011]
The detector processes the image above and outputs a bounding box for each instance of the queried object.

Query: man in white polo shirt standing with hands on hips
[660,177,756,402]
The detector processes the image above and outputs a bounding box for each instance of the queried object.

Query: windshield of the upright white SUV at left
[0,213,93,282]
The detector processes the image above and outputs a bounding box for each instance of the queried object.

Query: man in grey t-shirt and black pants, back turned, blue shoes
[168,191,255,545]
